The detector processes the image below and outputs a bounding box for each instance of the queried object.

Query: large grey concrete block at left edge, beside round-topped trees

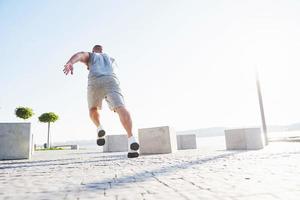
[0,123,32,160]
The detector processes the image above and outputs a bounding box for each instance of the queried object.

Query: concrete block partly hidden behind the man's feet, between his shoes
[103,134,128,152]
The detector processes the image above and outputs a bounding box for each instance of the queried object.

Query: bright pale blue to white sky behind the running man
[0,0,300,143]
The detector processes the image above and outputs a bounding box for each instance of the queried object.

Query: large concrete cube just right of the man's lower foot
[138,126,177,155]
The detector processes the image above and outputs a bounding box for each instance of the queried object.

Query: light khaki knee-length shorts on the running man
[87,76,125,111]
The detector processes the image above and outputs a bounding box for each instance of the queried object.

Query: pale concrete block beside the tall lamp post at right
[225,128,265,150]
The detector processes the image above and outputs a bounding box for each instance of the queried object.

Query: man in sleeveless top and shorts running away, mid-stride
[63,45,139,158]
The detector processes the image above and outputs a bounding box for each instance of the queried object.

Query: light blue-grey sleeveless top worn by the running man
[88,53,117,79]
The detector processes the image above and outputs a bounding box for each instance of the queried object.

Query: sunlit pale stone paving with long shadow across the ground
[0,142,300,200]
